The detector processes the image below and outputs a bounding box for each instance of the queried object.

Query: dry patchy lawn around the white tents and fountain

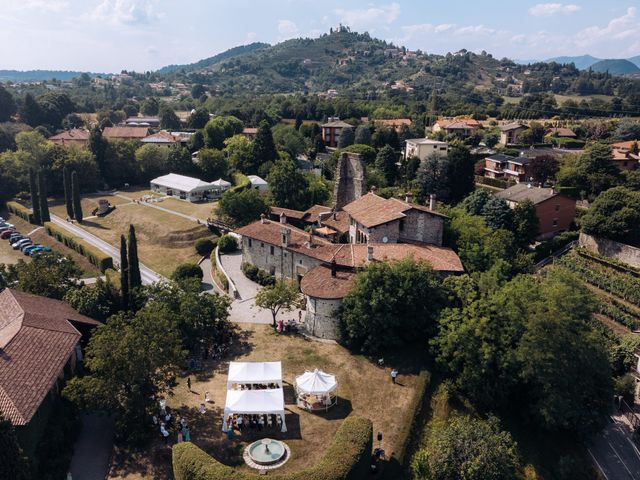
[109,324,419,480]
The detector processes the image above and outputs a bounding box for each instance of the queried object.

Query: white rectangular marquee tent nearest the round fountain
[222,388,287,432]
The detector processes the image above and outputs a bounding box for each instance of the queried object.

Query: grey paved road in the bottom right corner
[589,417,640,480]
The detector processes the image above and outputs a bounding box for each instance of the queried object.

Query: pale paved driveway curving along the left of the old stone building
[220,251,299,324]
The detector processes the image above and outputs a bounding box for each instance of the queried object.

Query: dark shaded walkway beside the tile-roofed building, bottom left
[70,413,114,480]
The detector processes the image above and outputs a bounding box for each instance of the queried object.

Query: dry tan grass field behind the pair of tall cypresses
[74,204,209,276]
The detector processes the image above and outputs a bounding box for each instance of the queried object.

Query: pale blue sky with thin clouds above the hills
[0,0,640,72]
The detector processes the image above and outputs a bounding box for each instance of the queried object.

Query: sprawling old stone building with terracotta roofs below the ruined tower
[236,189,463,339]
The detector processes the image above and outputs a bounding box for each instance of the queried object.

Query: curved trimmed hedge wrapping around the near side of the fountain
[173,416,373,480]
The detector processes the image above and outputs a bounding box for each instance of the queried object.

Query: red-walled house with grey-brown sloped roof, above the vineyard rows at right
[495,183,576,239]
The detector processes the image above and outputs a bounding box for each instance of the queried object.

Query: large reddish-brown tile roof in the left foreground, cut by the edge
[0,289,99,425]
